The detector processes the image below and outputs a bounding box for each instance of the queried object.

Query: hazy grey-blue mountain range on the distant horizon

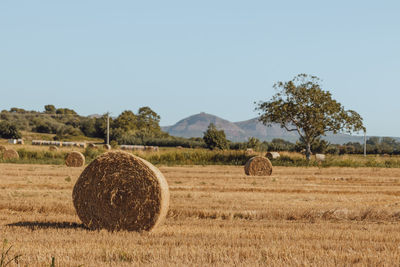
[162,112,364,144]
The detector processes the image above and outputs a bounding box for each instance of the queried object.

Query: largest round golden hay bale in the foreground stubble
[72,151,169,231]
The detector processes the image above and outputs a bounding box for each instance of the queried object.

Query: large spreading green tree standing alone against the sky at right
[256,74,365,160]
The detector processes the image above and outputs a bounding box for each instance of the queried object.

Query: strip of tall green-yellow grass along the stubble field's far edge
[0,145,400,168]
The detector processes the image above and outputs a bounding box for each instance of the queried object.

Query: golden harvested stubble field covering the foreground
[0,164,400,266]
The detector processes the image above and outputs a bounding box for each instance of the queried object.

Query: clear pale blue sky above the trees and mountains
[0,0,400,136]
